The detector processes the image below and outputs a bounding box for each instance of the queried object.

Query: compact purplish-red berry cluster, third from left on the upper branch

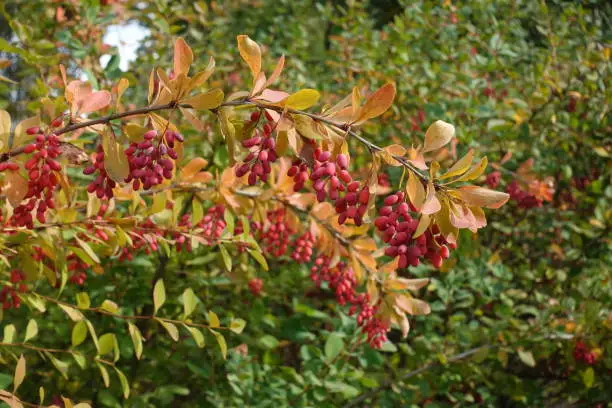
[125,130,184,191]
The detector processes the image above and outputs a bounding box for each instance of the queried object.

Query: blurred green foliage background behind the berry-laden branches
[0,0,612,407]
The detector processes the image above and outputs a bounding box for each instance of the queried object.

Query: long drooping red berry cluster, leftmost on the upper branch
[11,127,62,228]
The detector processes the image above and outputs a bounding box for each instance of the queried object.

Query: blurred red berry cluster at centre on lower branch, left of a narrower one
[251,207,295,258]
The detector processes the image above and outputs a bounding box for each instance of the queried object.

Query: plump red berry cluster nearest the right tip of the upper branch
[374,191,455,268]
